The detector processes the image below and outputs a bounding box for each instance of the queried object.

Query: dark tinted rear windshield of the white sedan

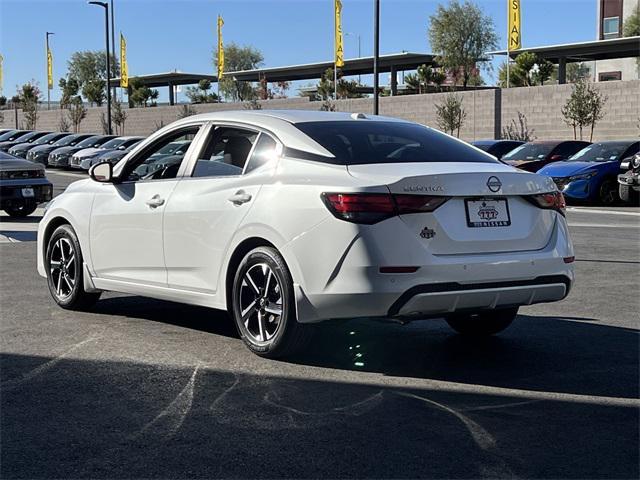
[292,120,498,165]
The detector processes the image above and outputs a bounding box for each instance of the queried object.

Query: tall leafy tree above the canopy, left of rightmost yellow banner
[429,0,498,87]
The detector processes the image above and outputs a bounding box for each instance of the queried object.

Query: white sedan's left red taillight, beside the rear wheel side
[322,193,448,225]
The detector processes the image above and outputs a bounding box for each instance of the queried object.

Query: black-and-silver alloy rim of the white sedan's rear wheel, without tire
[239,263,283,344]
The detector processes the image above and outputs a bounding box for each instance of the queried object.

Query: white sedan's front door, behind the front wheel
[90,124,202,287]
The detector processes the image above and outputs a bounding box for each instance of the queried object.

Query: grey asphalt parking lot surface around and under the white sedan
[0,172,640,478]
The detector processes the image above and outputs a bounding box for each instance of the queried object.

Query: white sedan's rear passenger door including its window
[164,125,278,294]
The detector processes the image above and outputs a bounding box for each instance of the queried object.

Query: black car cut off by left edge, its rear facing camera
[0,152,53,217]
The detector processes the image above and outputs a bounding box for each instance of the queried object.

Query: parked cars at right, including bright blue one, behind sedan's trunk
[473,139,640,205]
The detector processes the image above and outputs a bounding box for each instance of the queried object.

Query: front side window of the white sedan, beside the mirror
[121,125,200,182]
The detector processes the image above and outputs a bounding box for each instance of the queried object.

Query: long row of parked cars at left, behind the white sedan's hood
[0,130,143,170]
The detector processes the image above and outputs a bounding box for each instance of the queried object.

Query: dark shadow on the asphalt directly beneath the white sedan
[93,296,640,398]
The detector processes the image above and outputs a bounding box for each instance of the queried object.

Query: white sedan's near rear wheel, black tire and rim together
[232,247,312,358]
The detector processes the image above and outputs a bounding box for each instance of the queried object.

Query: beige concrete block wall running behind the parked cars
[0,80,640,141]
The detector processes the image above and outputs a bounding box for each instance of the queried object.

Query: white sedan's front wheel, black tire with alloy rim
[45,225,100,310]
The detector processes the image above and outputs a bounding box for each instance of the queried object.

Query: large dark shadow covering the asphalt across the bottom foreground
[0,342,638,479]
